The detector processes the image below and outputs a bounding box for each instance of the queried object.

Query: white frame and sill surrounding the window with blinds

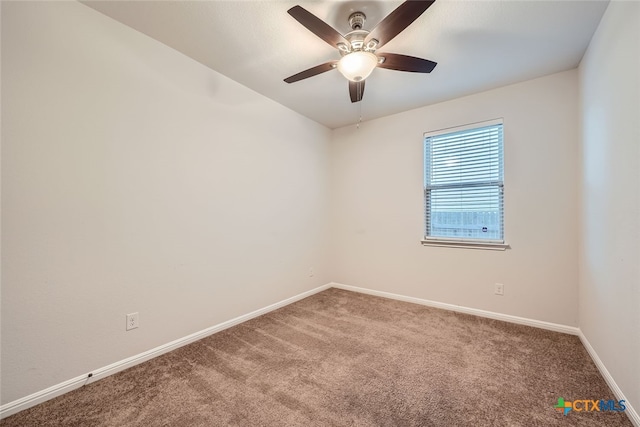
[421,118,510,251]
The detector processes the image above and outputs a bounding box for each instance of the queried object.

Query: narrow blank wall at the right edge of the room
[579,1,640,414]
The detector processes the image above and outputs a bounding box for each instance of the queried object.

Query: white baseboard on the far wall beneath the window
[329,283,580,335]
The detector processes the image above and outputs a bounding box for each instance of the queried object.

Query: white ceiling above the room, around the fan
[83,0,608,128]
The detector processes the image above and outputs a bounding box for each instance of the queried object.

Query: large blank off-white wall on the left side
[1,2,330,404]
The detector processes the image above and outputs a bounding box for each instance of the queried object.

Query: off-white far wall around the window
[331,70,579,326]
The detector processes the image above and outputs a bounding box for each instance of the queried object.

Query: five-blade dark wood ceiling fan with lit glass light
[284,0,436,102]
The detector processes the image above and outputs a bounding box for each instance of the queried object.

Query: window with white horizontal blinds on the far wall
[422,120,507,249]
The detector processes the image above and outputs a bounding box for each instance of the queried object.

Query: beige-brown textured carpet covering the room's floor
[0,289,631,427]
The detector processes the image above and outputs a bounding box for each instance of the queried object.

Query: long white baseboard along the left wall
[0,284,331,419]
